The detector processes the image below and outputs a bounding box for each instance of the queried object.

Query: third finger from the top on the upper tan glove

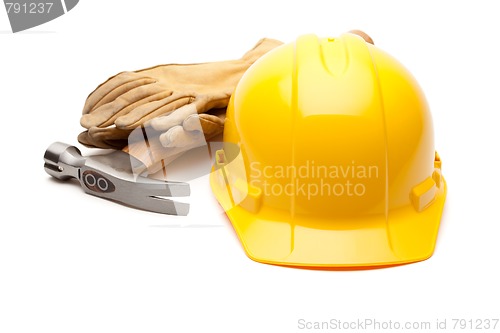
[115,93,194,128]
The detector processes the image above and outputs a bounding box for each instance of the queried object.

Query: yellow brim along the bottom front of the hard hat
[212,174,446,268]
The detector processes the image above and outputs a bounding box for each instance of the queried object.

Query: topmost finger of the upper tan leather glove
[82,72,155,114]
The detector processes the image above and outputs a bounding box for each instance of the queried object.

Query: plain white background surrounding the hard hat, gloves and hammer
[0,0,500,333]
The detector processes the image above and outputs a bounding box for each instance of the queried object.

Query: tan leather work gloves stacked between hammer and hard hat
[78,39,282,149]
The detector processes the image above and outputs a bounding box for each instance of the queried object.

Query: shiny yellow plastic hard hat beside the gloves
[210,33,446,267]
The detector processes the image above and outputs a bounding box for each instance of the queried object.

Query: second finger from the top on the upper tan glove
[80,84,172,128]
